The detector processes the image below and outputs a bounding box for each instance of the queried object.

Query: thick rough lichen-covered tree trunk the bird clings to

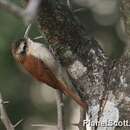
[38,0,130,130]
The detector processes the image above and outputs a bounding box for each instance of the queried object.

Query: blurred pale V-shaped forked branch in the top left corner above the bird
[0,0,41,24]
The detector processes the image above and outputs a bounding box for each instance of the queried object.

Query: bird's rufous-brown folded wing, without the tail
[23,55,58,89]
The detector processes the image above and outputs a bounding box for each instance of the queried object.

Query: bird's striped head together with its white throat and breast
[12,38,46,63]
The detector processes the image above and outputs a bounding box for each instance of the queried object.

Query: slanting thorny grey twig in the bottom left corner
[0,94,15,130]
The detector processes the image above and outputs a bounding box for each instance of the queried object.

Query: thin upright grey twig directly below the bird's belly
[56,90,65,130]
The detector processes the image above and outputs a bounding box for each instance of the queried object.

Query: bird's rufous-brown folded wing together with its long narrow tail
[24,55,86,108]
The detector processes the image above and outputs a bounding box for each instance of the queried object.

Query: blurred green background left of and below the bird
[0,0,73,130]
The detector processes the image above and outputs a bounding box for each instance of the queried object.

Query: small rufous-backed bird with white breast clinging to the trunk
[11,37,87,109]
